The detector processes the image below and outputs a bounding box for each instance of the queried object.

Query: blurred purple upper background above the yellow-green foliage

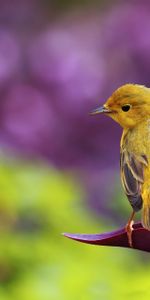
[0,0,150,220]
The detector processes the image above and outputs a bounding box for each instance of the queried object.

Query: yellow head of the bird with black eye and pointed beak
[91,84,150,128]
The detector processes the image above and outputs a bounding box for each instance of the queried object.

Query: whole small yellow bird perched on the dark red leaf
[91,84,150,247]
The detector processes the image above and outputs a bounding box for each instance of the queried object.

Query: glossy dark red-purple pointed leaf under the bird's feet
[64,223,150,252]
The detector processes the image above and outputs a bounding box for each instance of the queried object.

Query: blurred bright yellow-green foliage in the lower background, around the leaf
[0,157,150,300]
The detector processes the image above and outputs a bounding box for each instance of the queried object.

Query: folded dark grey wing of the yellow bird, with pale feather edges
[120,150,148,211]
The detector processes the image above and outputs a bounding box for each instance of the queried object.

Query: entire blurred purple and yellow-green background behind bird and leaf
[0,0,150,300]
